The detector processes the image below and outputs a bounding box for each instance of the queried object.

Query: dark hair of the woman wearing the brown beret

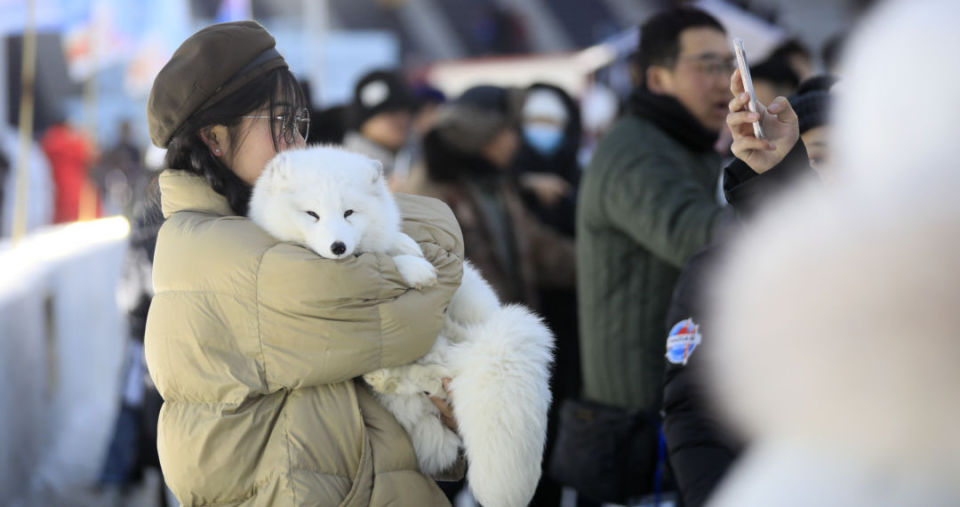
[165,68,306,216]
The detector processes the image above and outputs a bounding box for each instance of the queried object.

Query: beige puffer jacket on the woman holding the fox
[146,171,463,506]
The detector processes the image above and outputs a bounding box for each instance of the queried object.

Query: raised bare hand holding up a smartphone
[727,69,800,174]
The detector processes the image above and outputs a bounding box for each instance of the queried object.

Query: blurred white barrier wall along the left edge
[0,217,129,500]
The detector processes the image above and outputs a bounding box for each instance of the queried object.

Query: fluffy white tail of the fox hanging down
[449,305,554,507]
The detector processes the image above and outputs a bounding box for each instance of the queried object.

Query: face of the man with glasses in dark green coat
[651,27,734,131]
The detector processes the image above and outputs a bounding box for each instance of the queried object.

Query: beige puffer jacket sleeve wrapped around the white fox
[257,196,463,389]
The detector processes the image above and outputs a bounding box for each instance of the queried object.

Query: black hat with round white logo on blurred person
[350,70,415,129]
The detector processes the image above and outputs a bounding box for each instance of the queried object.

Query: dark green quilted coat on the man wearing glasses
[577,92,726,410]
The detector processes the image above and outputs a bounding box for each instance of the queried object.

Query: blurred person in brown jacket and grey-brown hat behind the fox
[410,86,575,505]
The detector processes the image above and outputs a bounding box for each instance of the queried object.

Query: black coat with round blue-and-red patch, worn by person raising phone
[663,142,812,507]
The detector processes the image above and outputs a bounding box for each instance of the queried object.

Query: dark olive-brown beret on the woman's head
[147,21,287,148]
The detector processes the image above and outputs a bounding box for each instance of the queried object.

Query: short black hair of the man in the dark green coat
[635,7,727,79]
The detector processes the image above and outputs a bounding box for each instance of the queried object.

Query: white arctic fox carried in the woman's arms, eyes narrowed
[250,146,553,507]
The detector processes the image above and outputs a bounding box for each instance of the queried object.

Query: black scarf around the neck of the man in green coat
[627,89,719,151]
